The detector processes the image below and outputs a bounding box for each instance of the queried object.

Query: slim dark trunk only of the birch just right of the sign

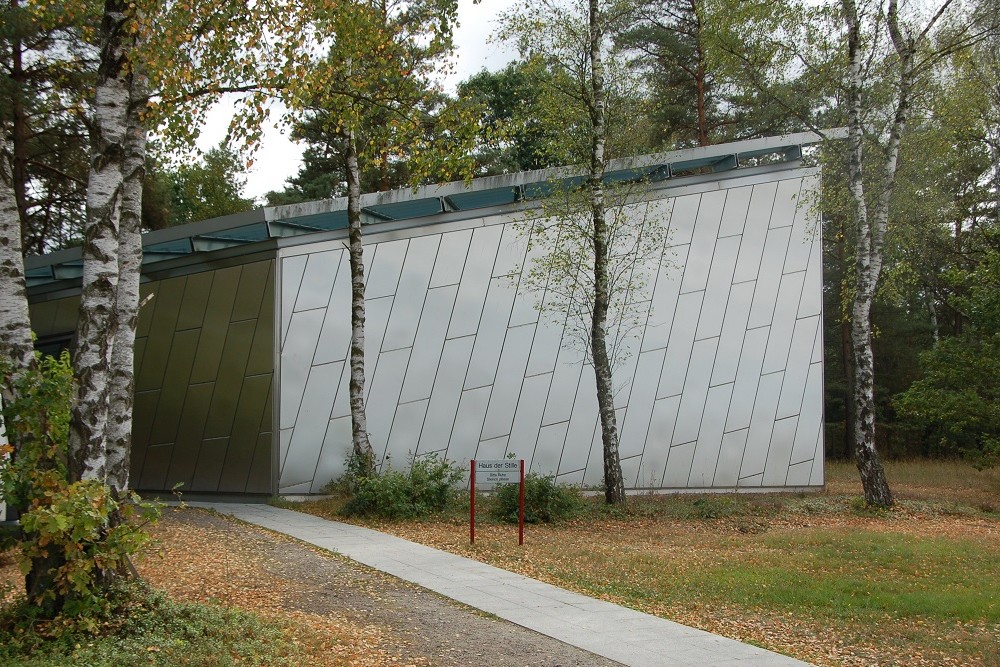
[588,0,625,504]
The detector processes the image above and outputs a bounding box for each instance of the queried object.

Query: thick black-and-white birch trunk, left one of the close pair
[69,0,130,481]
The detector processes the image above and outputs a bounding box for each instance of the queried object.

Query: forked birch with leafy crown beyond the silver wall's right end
[716,0,991,506]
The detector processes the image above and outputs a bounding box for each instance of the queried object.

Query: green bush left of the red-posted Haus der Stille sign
[338,455,464,519]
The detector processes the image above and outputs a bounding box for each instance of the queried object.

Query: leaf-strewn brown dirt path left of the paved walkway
[137,509,618,667]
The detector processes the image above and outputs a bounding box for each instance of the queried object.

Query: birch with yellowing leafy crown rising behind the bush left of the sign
[286,0,471,476]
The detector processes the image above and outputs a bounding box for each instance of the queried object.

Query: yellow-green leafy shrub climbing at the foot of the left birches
[0,352,159,619]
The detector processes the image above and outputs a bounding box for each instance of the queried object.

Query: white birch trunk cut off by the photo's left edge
[0,132,35,384]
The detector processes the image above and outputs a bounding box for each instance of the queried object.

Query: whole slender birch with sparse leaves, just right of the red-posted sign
[501,0,648,504]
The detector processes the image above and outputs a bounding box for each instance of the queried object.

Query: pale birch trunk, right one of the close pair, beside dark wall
[106,73,146,492]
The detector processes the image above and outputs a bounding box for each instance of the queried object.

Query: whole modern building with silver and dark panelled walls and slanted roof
[27,133,824,494]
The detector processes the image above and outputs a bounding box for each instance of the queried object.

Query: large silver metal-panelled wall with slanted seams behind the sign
[277,168,823,493]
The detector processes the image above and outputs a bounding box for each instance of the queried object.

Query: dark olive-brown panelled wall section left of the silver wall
[31,260,274,494]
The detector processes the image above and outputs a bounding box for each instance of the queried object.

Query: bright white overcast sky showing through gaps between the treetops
[198,0,524,199]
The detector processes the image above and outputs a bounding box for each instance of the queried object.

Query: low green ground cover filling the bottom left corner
[0,584,301,667]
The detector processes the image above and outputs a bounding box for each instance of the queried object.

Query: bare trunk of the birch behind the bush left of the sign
[344,130,375,476]
